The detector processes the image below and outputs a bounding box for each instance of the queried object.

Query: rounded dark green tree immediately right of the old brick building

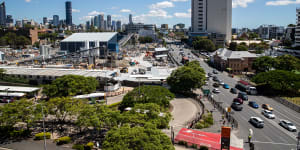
[252,56,276,73]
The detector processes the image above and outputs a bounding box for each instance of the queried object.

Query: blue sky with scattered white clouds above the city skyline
[0,0,300,28]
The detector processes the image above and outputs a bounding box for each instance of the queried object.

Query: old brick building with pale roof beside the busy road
[211,48,257,74]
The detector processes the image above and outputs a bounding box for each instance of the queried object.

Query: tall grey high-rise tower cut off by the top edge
[191,0,232,41]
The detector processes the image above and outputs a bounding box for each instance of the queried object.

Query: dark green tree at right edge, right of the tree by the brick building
[275,55,300,71]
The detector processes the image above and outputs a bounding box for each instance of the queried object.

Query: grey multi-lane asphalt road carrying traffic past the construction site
[171,45,300,150]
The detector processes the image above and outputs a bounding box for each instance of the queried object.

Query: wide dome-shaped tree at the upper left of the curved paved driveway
[119,86,175,110]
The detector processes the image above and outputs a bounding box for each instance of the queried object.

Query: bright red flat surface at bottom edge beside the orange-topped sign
[175,128,243,150]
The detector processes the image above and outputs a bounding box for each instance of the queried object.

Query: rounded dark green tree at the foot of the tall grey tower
[193,39,216,52]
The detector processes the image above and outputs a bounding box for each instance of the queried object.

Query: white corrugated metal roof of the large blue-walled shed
[62,32,118,42]
